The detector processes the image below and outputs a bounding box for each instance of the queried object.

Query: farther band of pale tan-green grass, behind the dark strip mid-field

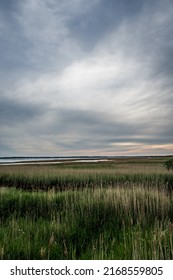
[0,161,173,191]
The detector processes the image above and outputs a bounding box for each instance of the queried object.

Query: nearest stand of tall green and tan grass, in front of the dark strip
[0,185,173,259]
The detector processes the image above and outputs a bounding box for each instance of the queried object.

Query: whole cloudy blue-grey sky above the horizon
[0,0,173,157]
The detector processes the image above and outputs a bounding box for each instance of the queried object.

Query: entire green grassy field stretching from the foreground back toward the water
[0,157,173,260]
